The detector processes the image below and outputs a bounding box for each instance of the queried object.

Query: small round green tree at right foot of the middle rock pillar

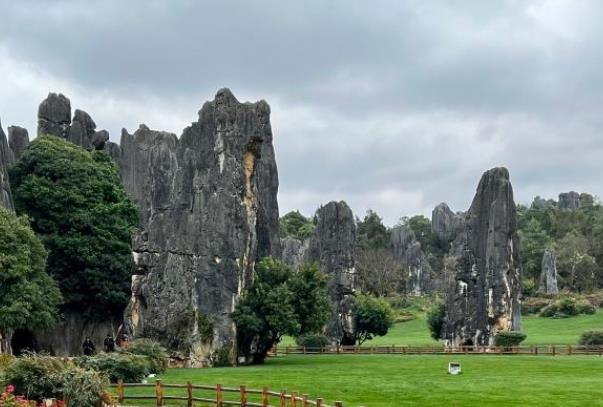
[352,294,394,345]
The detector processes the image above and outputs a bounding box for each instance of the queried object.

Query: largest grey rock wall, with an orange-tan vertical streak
[122,89,280,361]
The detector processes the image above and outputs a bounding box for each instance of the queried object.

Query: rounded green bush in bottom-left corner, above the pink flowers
[2,353,67,400]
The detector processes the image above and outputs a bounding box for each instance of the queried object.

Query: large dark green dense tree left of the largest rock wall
[10,136,138,318]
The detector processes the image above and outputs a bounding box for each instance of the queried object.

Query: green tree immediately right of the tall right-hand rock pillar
[519,218,552,285]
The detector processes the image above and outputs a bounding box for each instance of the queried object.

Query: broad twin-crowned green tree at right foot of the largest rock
[232,257,330,364]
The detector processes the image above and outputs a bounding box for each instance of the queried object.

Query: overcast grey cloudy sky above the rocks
[0,0,603,225]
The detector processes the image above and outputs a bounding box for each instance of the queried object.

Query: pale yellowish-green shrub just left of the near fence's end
[59,365,108,407]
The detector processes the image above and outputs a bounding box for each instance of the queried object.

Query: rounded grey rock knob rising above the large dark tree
[38,93,71,138]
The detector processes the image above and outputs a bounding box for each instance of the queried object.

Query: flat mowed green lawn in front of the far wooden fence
[126,355,603,407]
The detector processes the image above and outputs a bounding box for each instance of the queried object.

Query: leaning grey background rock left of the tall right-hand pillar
[391,226,432,295]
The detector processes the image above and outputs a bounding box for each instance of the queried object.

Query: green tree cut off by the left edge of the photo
[0,207,61,351]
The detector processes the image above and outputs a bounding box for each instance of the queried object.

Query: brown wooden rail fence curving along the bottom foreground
[111,380,354,407]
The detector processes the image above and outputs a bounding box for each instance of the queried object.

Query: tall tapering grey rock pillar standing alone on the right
[443,168,521,346]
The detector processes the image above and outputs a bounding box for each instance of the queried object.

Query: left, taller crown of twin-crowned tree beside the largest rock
[232,258,300,364]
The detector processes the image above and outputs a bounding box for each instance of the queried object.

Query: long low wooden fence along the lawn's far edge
[271,345,603,356]
